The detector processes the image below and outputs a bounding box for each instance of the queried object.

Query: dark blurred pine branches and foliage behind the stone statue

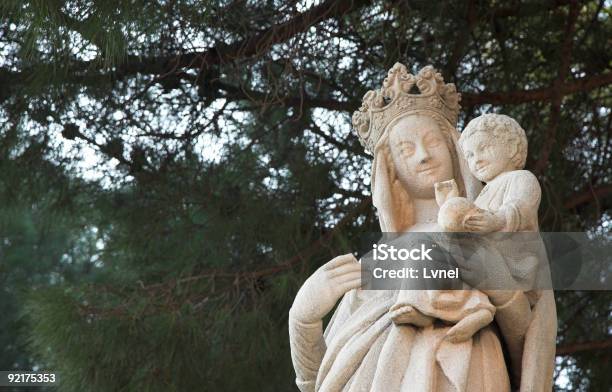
[0,0,612,391]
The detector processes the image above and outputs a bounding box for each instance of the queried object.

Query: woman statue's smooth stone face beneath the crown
[389,115,453,199]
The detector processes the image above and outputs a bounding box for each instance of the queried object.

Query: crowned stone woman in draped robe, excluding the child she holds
[289,64,557,392]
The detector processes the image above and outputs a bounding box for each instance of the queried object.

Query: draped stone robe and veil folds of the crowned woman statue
[289,119,557,392]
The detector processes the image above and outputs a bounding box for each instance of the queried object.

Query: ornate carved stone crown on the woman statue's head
[352,63,461,154]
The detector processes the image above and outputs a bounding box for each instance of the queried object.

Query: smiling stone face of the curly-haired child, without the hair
[461,131,514,182]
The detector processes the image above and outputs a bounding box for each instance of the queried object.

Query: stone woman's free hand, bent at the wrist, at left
[289,253,361,323]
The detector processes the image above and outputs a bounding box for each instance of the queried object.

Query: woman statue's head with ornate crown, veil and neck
[352,63,481,231]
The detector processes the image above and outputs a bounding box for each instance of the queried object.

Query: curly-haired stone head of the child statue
[459,113,527,182]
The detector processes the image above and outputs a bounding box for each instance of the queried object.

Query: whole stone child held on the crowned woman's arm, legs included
[390,114,541,342]
